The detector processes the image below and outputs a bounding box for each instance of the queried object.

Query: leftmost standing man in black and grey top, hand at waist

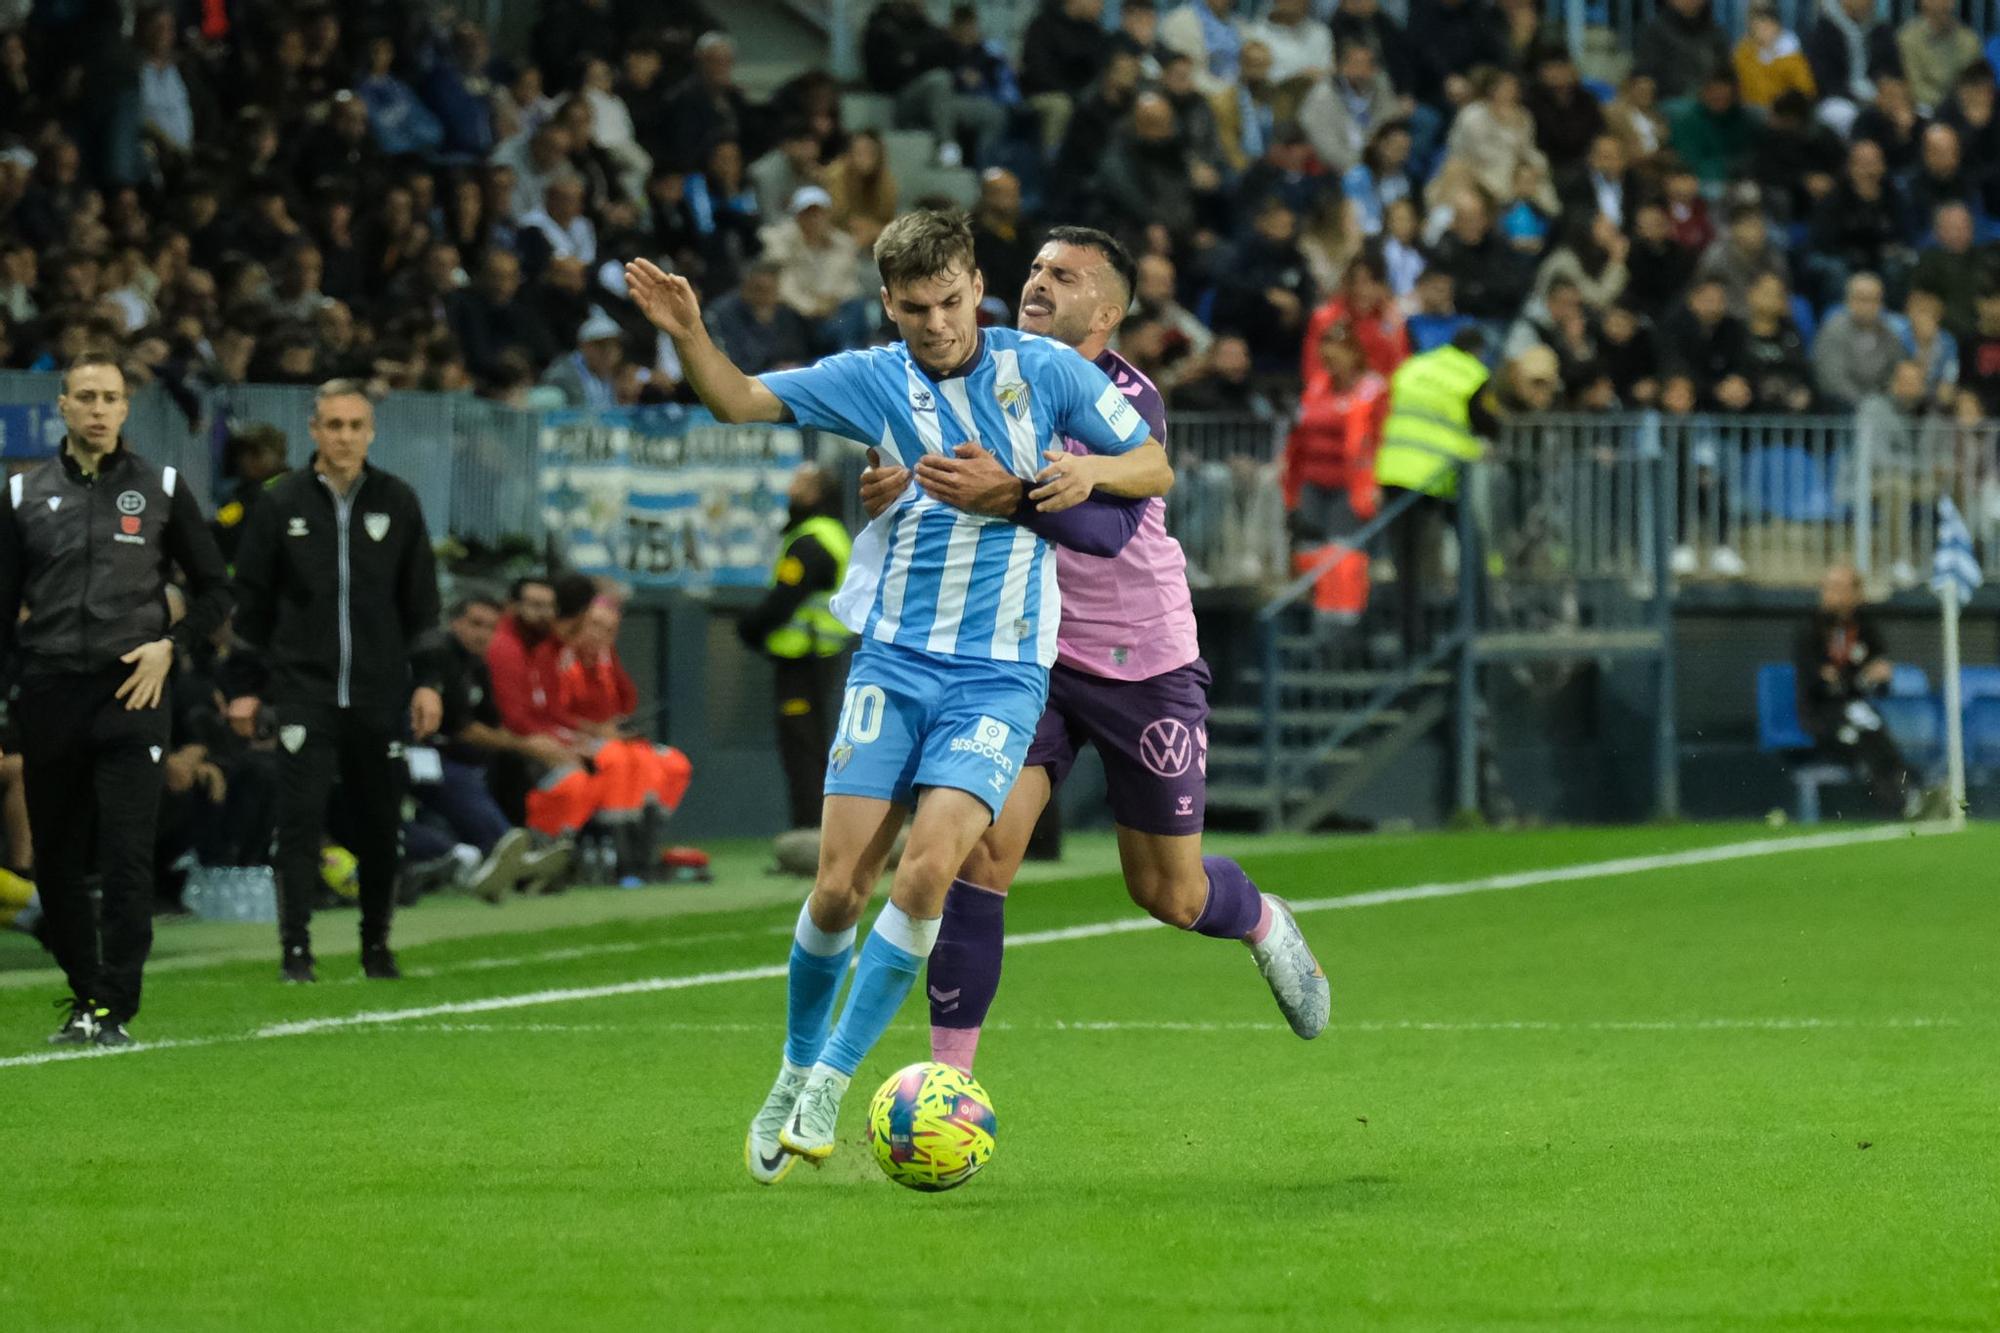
[0,356,230,1045]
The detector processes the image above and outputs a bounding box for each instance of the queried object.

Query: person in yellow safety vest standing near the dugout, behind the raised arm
[736,462,852,829]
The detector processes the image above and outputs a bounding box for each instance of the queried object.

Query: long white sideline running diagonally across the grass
[0,823,1958,1069]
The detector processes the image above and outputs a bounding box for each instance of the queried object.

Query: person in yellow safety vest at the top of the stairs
[1376,328,1558,658]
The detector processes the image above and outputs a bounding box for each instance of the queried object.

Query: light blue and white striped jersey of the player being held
[760,328,1150,667]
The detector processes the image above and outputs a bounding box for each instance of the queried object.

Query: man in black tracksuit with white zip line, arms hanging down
[236,380,444,981]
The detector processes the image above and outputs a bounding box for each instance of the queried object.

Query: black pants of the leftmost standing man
[16,664,172,1023]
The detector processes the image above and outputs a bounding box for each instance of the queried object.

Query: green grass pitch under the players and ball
[0,827,2000,1333]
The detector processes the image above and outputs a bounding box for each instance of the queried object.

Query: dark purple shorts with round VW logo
[1028,658,1208,837]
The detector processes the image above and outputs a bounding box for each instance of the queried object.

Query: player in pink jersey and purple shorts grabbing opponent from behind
[862,226,1330,1073]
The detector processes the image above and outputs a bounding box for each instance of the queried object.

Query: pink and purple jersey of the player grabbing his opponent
[1056,350,1202,681]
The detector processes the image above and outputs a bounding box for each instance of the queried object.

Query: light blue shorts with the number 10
[826,638,1048,815]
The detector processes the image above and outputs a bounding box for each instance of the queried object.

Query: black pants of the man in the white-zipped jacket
[278,705,408,949]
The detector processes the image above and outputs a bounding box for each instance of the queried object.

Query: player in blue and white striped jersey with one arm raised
[626,212,1174,1185]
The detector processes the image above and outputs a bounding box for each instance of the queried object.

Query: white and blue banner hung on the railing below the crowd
[540,406,804,588]
